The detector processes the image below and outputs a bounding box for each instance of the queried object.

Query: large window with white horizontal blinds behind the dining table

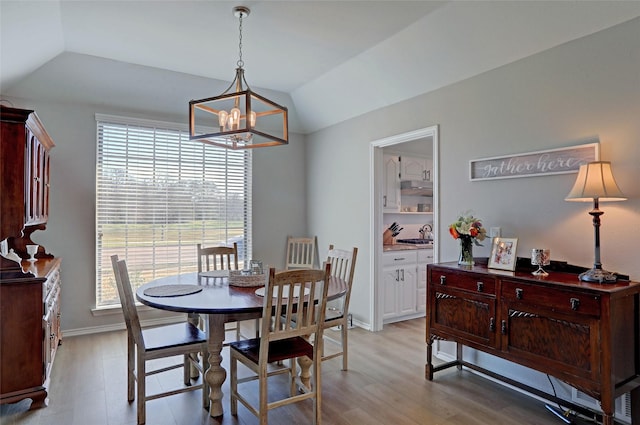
[96,114,251,307]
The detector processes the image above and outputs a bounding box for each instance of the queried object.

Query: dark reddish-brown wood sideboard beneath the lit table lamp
[425,263,640,425]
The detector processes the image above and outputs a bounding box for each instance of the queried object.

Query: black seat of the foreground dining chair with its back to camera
[229,336,313,364]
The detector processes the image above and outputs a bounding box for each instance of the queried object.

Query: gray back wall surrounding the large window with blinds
[2,98,306,336]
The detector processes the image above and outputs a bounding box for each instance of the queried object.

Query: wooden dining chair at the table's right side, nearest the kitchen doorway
[322,245,358,370]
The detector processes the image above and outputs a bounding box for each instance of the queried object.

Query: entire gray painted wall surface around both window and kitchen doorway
[2,19,640,338]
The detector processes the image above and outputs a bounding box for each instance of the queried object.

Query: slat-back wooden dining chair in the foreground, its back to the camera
[229,264,331,425]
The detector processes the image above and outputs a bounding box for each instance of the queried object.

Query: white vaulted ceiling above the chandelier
[0,0,640,133]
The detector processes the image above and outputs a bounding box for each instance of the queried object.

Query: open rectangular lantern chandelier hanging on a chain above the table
[189,6,289,150]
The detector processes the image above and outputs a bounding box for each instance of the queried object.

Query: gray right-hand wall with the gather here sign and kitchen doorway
[306,18,640,323]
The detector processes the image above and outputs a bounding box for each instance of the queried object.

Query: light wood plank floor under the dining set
[0,319,560,425]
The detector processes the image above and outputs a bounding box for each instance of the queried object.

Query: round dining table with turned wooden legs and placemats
[136,272,347,417]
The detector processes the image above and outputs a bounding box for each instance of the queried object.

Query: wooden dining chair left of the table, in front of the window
[111,255,209,424]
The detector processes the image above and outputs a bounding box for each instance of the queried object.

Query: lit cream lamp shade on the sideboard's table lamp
[565,161,627,202]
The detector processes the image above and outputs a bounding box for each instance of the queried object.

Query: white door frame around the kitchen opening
[369,125,440,331]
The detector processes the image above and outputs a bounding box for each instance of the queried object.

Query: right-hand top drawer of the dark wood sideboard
[501,280,600,316]
